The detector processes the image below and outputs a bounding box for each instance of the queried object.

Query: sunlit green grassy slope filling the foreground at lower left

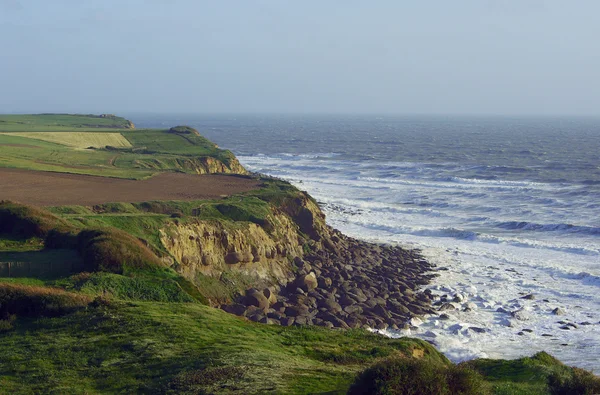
[0,302,447,394]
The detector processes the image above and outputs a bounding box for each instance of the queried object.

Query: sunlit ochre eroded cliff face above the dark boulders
[160,194,331,300]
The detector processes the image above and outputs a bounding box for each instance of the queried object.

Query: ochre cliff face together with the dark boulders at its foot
[161,187,431,329]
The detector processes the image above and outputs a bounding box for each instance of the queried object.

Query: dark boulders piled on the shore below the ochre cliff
[221,231,435,329]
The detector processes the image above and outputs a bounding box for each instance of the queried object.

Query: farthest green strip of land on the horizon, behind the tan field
[0,114,132,132]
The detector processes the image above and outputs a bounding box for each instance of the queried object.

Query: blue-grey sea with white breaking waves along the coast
[131,114,600,373]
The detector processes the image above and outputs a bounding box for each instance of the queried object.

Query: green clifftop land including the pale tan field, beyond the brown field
[0,130,234,179]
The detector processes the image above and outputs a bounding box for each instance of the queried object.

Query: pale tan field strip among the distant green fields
[5,132,131,149]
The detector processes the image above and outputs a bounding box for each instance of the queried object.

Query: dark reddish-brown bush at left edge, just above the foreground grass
[0,283,91,319]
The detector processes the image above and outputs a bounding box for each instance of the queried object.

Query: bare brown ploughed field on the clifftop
[0,168,259,206]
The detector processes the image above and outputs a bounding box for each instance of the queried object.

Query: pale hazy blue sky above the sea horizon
[0,0,600,116]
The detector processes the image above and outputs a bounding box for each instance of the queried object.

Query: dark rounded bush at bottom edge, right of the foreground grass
[348,358,486,395]
